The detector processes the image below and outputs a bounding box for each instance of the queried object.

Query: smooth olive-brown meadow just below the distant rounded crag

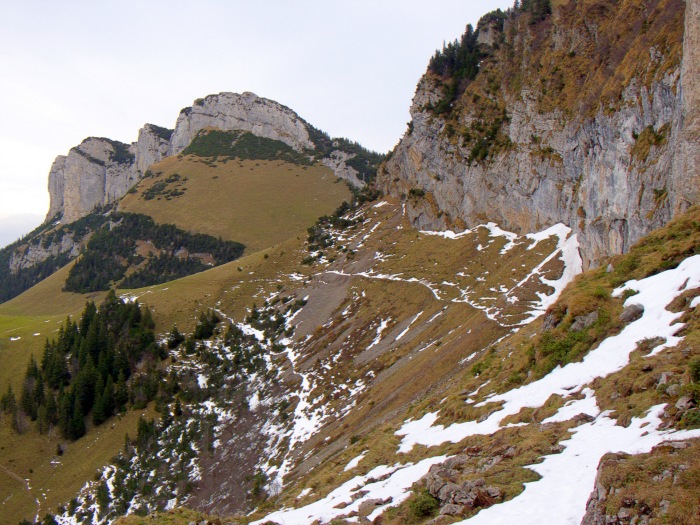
[120,156,350,253]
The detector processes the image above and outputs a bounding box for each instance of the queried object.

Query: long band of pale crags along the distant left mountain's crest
[46,93,371,223]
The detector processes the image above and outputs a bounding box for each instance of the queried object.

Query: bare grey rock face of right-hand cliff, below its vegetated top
[378,0,700,266]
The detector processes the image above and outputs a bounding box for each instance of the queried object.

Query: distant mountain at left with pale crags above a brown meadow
[0,93,383,301]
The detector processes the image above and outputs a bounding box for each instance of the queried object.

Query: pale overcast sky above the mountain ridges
[0,0,513,246]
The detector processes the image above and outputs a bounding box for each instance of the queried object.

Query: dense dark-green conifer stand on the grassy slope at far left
[0,291,161,440]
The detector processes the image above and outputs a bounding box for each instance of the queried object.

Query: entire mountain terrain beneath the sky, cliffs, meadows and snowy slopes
[0,0,700,525]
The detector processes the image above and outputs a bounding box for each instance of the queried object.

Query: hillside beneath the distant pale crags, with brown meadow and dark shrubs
[0,131,351,301]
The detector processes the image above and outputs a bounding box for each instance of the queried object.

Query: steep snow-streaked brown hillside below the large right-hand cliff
[16,200,700,524]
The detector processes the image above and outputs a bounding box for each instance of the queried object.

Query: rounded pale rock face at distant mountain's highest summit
[169,93,314,155]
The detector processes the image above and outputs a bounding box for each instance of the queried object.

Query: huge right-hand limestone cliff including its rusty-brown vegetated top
[378,0,698,264]
